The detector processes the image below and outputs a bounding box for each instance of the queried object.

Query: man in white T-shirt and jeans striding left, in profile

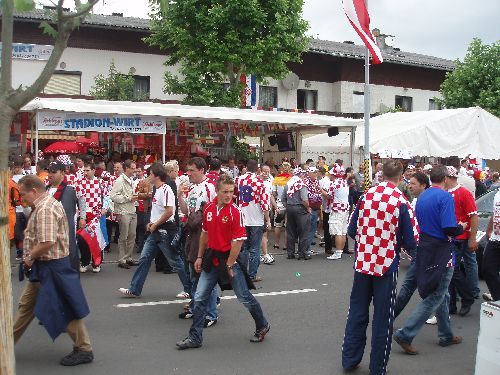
[119,163,190,297]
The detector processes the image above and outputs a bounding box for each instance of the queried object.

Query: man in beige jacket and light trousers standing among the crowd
[109,160,137,268]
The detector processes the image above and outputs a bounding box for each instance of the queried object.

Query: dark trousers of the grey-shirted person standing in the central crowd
[286,205,311,257]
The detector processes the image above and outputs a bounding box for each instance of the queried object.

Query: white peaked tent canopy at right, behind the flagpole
[355,107,500,159]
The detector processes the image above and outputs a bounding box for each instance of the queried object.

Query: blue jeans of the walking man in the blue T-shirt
[394,267,453,344]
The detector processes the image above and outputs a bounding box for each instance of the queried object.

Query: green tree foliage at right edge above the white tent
[440,39,500,116]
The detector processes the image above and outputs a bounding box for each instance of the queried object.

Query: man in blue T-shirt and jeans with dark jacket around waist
[394,165,466,355]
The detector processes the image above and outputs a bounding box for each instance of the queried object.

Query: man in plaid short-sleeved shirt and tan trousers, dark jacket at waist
[14,175,94,366]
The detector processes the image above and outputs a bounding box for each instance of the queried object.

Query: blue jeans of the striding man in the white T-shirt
[130,230,191,296]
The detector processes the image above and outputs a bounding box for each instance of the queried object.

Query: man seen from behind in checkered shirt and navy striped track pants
[342,160,418,375]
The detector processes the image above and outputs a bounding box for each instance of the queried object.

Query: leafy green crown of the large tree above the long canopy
[146,0,308,106]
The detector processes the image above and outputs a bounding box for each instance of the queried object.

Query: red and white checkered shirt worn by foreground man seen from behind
[355,181,419,276]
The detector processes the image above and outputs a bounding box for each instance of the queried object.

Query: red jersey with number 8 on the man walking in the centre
[201,198,247,252]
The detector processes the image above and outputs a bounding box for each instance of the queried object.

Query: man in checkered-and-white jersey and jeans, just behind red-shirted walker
[235,160,271,282]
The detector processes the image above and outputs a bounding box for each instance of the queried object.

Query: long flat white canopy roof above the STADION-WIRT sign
[21,98,360,127]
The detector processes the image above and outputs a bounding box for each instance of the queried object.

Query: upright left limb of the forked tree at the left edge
[0,0,14,95]
